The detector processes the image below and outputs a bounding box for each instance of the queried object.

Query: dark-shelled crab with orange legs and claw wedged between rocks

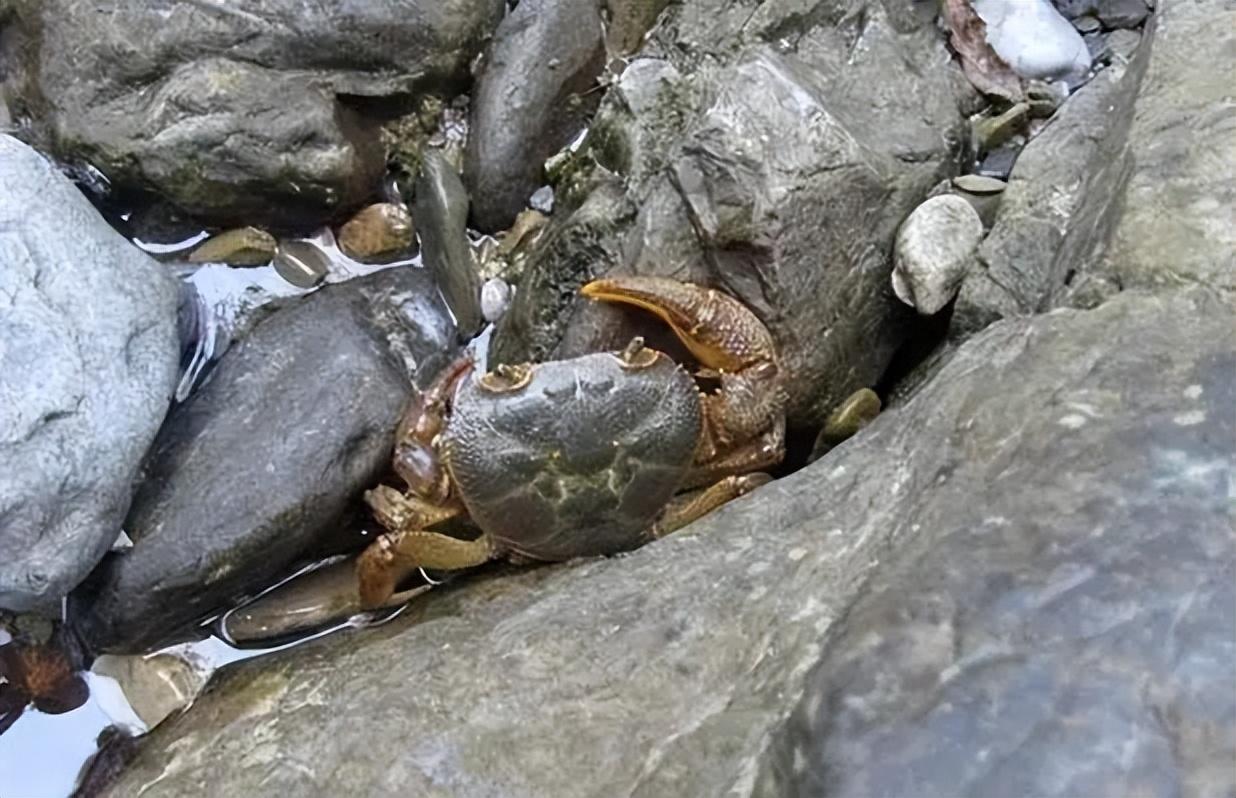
[356,277,785,607]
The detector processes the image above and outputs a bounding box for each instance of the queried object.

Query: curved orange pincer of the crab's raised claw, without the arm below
[580,277,776,373]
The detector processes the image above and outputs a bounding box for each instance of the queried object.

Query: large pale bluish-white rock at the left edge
[0,136,179,616]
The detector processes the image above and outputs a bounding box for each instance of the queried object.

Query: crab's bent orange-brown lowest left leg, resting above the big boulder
[356,529,497,608]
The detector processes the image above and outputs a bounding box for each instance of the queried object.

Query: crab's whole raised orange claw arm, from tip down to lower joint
[581,277,785,473]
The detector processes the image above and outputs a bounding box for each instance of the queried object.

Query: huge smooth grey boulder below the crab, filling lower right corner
[101,290,1236,798]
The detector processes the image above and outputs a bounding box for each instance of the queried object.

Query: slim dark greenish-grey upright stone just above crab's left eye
[414,152,481,337]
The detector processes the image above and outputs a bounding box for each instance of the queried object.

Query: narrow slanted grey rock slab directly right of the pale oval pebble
[952,26,1146,336]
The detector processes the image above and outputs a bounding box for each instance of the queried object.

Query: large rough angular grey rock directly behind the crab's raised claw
[491,1,969,429]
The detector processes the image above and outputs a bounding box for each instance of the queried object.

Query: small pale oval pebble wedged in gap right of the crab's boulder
[892,194,983,316]
